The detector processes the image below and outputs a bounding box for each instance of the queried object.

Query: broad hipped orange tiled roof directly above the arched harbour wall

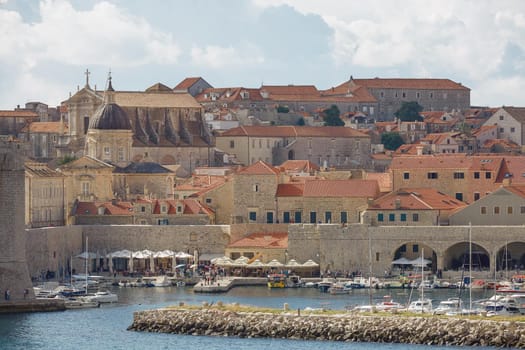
[368,188,467,210]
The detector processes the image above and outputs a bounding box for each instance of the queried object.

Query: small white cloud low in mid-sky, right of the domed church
[191,45,264,68]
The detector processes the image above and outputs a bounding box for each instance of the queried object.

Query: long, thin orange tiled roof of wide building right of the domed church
[218,125,369,137]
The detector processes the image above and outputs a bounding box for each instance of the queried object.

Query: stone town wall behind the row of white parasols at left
[24,225,230,278]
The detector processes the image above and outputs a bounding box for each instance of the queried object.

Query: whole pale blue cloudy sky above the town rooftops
[0,0,525,110]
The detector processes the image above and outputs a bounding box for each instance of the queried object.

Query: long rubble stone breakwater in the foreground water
[128,309,525,348]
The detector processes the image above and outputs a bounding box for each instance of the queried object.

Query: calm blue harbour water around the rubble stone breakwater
[0,287,500,350]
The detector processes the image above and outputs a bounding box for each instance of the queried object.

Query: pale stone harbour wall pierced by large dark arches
[288,224,525,276]
